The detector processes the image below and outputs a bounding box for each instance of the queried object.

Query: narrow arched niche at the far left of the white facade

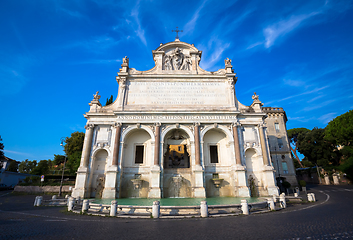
[91,149,108,198]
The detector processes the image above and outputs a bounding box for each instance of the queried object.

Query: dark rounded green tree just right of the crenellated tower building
[297,128,340,171]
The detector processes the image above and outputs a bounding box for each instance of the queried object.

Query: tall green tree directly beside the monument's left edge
[64,132,85,173]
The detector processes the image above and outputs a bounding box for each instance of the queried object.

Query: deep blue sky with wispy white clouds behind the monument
[0,0,353,161]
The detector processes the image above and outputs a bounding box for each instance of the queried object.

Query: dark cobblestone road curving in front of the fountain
[0,186,353,240]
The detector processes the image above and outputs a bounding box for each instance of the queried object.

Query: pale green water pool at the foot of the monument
[94,197,265,206]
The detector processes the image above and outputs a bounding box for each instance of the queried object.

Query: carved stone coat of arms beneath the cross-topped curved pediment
[163,47,192,70]
